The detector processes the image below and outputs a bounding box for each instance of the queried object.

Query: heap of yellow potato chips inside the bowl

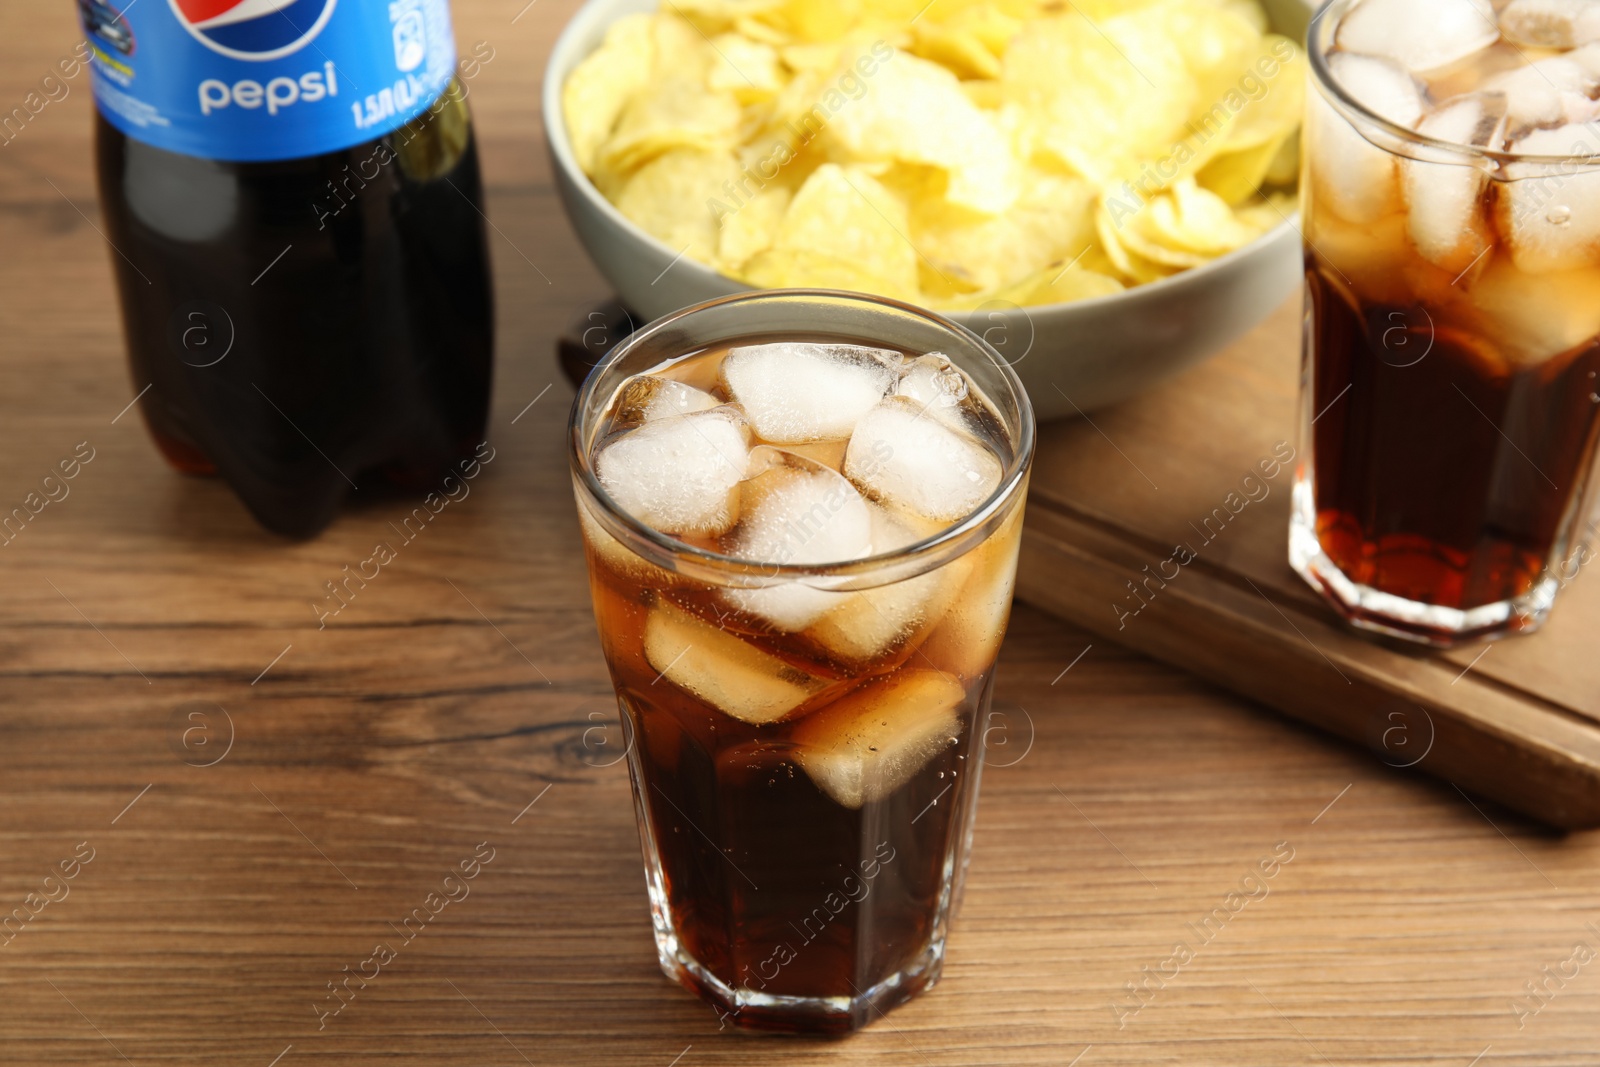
[563,0,1306,310]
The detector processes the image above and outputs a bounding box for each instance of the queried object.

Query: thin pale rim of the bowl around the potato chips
[541,0,1306,322]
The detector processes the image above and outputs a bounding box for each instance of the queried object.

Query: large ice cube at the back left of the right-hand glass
[1336,0,1499,74]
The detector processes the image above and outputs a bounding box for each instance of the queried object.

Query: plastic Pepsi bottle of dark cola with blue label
[78,0,493,536]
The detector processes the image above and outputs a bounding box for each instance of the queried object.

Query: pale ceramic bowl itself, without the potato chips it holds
[544,0,1310,419]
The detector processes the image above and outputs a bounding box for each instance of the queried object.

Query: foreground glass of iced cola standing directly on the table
[574,298,1032,1032]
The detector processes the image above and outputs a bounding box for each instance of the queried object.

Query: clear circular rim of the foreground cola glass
[566,288,1037,584]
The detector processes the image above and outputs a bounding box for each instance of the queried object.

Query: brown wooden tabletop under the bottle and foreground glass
[0,0,1600,1067]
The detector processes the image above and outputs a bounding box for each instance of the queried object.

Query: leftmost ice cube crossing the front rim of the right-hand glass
[1307,53,1422,226]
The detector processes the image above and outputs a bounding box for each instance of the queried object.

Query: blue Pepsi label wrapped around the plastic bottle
[78,0,456,162]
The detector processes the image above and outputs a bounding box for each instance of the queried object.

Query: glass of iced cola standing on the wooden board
[1291,0,1600,645]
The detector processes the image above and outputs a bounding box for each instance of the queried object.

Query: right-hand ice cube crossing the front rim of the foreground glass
[810,504,973,664]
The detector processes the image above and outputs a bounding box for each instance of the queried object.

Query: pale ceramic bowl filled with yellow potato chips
[544,0,1310,418]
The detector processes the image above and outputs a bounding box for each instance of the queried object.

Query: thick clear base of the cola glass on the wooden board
[1290,478,1560,648]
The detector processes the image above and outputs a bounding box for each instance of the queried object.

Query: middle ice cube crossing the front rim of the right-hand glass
[1400,94,1506,274]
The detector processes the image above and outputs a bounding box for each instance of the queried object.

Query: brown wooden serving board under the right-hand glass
[1018,298,1600,829]
